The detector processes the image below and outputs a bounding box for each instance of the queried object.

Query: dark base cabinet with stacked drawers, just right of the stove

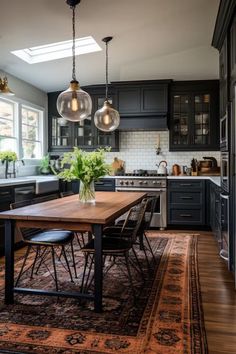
[168,179,205,226]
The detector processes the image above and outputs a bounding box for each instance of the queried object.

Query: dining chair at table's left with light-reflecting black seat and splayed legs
[10,200,74,291]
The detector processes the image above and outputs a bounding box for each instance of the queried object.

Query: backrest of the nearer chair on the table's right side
[121,203,146,243]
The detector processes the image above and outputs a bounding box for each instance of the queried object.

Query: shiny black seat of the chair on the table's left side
[25,230,74,245]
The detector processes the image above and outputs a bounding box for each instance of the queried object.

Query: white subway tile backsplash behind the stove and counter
[107,131,220,171]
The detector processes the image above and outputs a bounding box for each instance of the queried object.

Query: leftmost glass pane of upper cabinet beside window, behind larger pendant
[52,117,71,147]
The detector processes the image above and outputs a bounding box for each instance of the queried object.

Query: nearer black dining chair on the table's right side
[81,203,145,297]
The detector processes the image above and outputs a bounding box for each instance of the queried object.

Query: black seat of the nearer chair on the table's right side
[81,237,130,254]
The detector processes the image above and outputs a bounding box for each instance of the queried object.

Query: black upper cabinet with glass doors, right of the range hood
[169,80,219,151]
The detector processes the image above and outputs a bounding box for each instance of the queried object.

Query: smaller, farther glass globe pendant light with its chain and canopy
[94,37,120,132]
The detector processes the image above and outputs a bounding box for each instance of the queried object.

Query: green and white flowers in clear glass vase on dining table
[58,147,111,203]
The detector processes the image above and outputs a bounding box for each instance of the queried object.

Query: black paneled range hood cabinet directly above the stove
[112,80,171,130]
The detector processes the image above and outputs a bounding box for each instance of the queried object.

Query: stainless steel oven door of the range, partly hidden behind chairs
[116,187,167,229]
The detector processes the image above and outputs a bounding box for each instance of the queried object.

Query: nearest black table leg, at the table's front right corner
[93,224,103,312]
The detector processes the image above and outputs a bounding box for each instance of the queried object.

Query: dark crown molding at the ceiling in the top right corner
[211,0,236,50]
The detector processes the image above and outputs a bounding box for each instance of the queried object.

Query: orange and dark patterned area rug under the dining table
[0,232,208,354]
